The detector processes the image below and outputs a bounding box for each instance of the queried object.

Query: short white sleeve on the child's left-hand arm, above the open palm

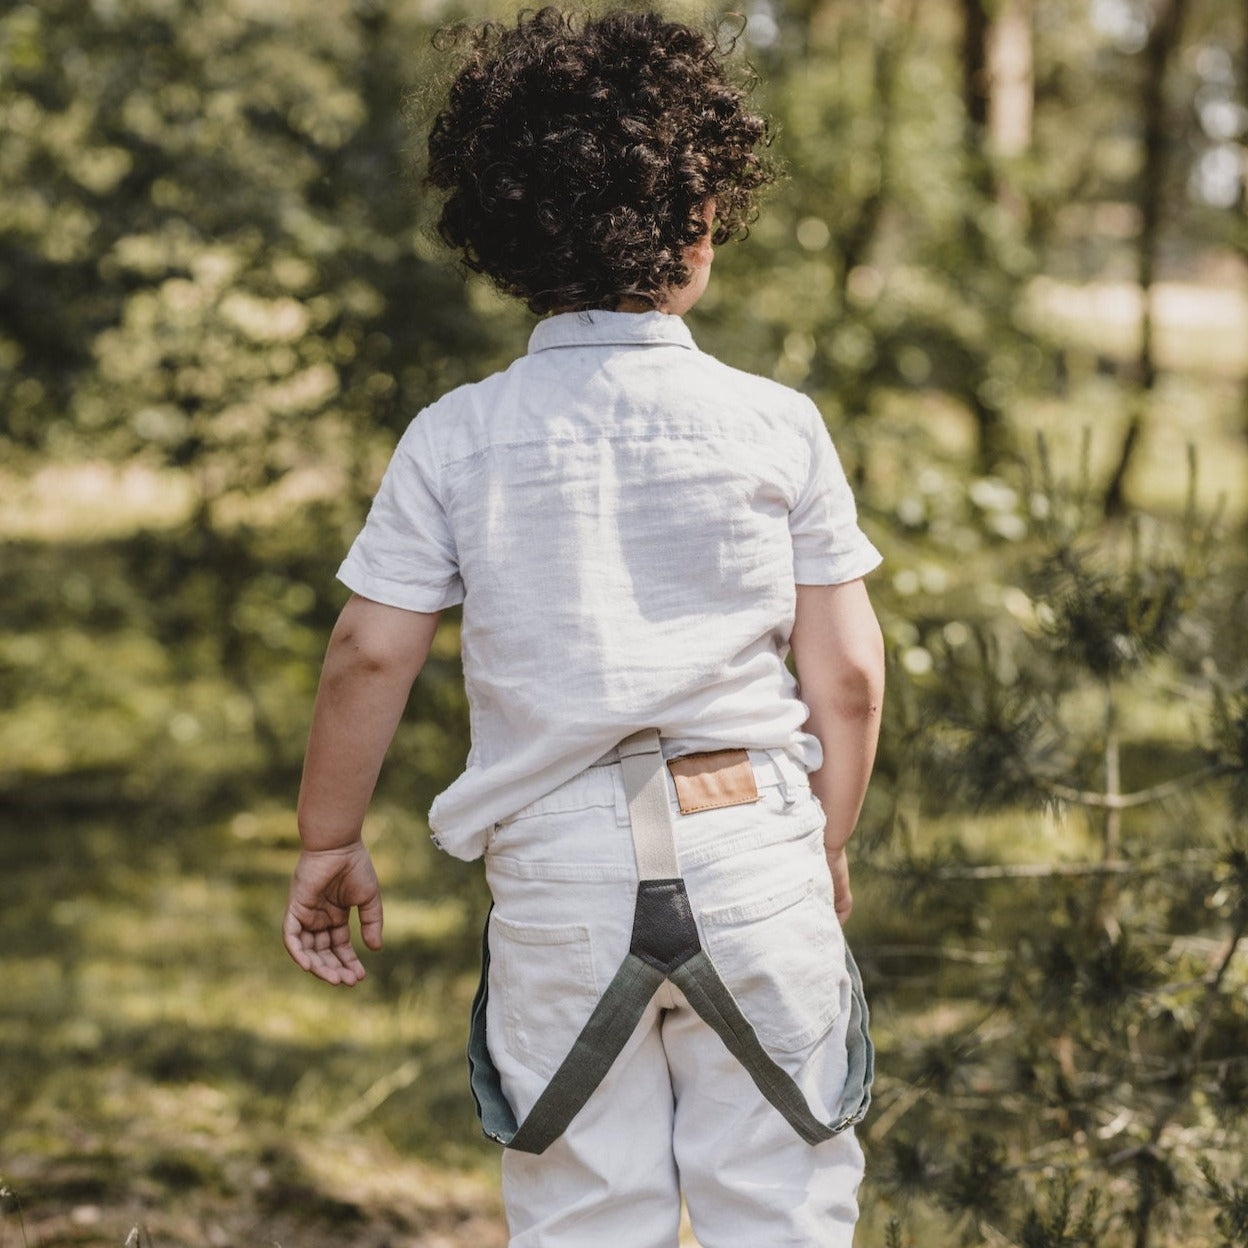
[338,417,464,612]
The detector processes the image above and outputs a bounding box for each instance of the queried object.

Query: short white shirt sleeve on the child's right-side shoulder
[789,401,882,585]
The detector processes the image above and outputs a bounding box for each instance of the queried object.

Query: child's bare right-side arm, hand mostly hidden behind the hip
[789,580,884,924]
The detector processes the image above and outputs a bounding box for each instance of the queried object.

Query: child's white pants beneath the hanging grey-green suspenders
[485,751,862,1248]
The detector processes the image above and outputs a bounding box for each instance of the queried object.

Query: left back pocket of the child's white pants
[489,911,599,1078]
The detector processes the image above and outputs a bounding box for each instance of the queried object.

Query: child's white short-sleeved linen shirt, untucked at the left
[338,311,880,859]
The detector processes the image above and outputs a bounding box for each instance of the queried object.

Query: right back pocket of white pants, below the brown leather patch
[701,879,845,1053]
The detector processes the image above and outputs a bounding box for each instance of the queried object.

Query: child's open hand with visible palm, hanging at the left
[282,841,382,987]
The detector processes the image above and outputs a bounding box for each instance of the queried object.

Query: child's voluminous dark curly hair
[424,7,776,314]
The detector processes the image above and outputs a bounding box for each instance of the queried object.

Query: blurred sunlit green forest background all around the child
[0,0,1248,1248]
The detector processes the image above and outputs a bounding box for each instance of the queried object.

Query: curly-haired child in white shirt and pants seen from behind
[283,9,882,1248]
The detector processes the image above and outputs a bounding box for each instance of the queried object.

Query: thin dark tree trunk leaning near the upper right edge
[1103,0,1188,515]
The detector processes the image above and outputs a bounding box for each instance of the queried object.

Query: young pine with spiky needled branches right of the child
[886,436,1248,1244]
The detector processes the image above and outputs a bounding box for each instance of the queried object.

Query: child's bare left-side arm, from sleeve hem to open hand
[282,595,441,985]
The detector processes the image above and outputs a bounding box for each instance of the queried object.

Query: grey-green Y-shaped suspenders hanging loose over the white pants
[468,729,874,1153]
